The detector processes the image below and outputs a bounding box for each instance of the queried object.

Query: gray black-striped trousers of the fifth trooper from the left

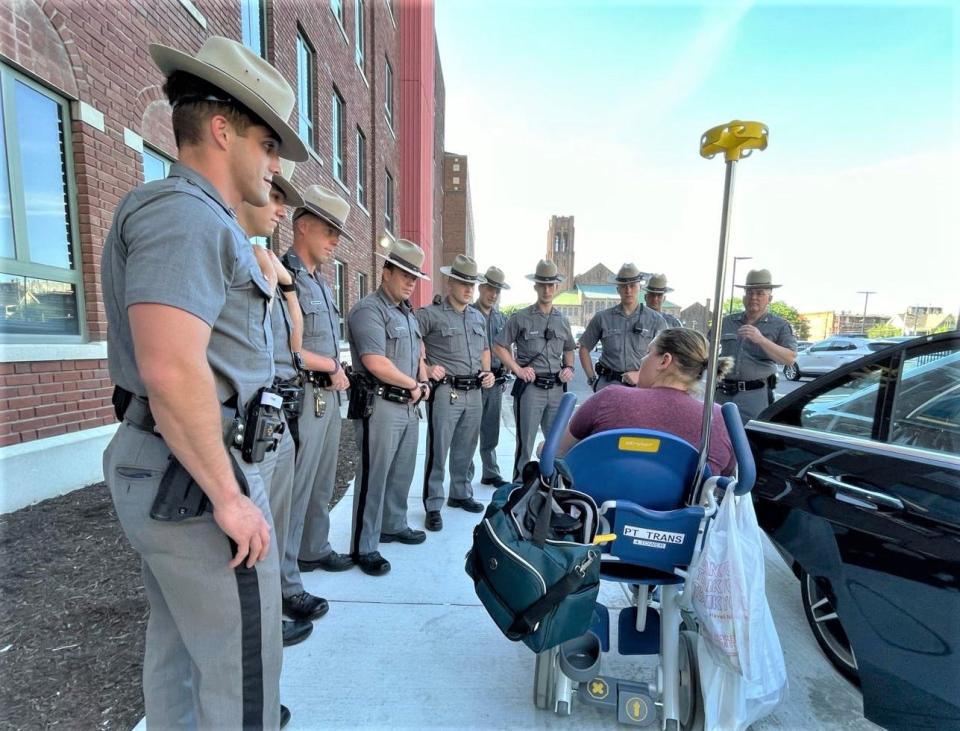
[423,383,480,510]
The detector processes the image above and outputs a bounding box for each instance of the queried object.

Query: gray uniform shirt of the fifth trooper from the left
[417,298,489,376]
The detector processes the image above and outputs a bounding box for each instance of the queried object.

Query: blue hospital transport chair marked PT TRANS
[534,394,756,731]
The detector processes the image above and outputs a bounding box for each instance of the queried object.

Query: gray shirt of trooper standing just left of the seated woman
[496,304,577,375]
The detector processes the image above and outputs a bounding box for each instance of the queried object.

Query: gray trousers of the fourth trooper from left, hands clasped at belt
[350,398,420,555]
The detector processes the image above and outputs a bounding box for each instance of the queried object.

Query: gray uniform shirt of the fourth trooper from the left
[347,288,422,381]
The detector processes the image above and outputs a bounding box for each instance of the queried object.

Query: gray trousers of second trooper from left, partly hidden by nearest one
[260,426,303,597]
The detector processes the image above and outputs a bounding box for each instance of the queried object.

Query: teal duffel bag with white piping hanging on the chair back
[466,463,600,652]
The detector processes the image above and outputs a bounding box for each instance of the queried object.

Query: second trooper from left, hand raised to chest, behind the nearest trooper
[237,162,329,647]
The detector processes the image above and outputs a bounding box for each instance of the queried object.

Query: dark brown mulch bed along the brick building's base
[0,422,357,730]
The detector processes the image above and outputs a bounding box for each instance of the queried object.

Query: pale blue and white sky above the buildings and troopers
[436,0,960,315]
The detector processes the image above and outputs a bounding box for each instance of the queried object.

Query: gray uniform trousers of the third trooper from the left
[293,383,342,561]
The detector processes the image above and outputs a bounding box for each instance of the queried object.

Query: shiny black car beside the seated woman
[747,331,960,729]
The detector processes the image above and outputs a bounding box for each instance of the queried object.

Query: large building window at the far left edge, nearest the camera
[0,64,83,341]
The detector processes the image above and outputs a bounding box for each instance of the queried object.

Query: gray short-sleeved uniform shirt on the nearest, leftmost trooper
[101,163,273,404]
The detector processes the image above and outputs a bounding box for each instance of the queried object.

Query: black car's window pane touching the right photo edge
[889,341,960,454]
